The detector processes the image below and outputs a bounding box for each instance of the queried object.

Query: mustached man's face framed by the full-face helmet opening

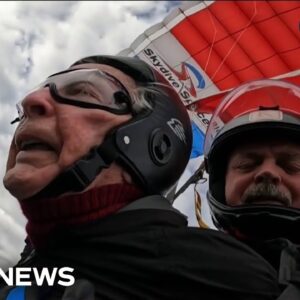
[225,140,300,208]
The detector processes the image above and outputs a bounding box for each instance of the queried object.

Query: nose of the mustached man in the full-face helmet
[254,161,281,184]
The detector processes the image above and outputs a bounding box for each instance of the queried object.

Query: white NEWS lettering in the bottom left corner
[0,267,75,286]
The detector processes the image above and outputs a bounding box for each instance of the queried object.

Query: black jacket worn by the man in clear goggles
[0,196,279,300]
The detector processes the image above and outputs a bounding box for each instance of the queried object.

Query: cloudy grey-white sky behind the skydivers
[0,1,213,268]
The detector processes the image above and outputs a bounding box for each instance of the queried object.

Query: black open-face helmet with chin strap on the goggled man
[34,55,192,198]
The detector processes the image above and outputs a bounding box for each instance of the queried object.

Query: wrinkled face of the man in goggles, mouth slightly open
[4,64,135,200]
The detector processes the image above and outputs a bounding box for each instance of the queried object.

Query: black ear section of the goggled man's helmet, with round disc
[113,87,192,193]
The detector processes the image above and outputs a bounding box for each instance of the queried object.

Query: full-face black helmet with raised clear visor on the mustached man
[204,79,300,241]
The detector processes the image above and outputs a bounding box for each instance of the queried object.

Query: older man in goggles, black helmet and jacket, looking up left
[0,56,279,300]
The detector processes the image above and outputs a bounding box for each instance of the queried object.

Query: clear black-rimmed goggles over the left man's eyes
[12,69,132,123]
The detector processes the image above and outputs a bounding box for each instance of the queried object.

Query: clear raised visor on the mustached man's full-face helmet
[204,79,300,155]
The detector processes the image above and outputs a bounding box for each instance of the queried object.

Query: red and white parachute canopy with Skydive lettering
[120,1,300,130]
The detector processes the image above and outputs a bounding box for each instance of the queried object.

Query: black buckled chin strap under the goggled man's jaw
[29,135,119,200]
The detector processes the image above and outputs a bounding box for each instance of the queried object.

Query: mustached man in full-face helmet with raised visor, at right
[205,79,300,300]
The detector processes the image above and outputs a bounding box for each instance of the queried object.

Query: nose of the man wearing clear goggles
[22,88,54,118]
